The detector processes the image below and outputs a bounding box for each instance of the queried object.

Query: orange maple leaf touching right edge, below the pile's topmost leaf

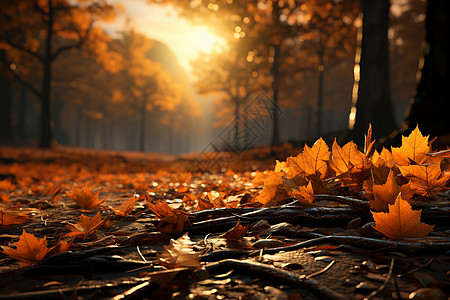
[399,157,450,197]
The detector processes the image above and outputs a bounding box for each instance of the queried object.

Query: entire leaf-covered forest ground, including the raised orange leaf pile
[0,128,450,299]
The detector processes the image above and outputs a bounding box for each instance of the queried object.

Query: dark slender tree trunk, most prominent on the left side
[39,0,55,148]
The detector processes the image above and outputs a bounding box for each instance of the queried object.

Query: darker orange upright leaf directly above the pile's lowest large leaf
[369,170,400,212]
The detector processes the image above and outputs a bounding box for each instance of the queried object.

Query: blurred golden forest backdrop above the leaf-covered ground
[0,0,442,153]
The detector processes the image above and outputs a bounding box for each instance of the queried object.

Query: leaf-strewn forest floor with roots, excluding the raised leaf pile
[0,145,450,300]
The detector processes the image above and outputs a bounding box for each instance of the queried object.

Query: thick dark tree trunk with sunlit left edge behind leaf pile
[349,0,396,144]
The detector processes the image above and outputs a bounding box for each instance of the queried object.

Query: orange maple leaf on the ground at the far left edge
[2,230,49,264]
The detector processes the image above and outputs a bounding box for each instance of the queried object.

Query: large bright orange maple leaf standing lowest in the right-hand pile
[372,194,434,240]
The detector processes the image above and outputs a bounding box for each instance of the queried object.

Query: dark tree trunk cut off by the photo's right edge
[397,0,450,140]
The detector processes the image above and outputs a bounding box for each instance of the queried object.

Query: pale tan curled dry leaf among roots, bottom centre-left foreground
[156,233,201,269]
